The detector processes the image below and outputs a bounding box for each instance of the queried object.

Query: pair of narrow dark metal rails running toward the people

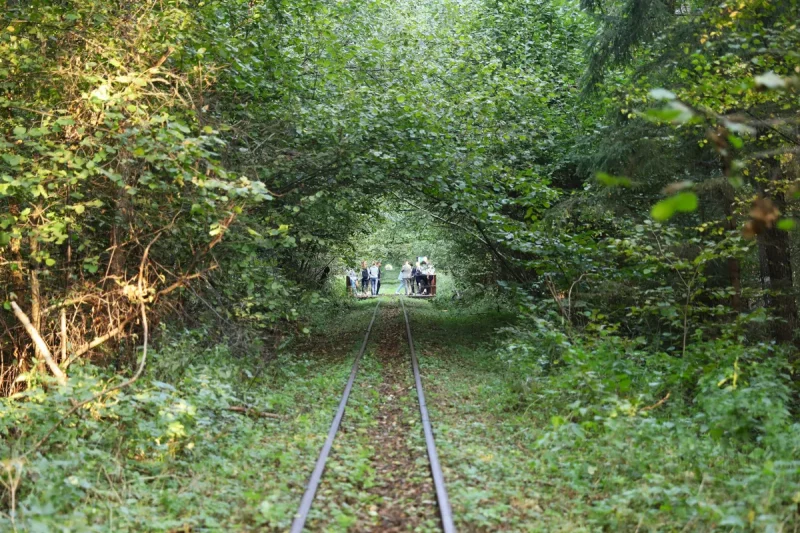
[290,298,455,533]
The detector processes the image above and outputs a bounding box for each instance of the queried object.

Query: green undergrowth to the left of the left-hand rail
[0,305,372,532]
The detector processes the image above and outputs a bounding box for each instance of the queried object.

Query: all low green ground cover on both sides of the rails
[6,297,800,532]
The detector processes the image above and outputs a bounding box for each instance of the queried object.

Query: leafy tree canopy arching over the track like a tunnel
[0,0,797,386]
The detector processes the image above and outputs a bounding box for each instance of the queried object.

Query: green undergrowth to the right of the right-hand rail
[412,306,800,532]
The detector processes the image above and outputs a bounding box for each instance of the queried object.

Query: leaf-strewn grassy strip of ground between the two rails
[294,302,451,532]
